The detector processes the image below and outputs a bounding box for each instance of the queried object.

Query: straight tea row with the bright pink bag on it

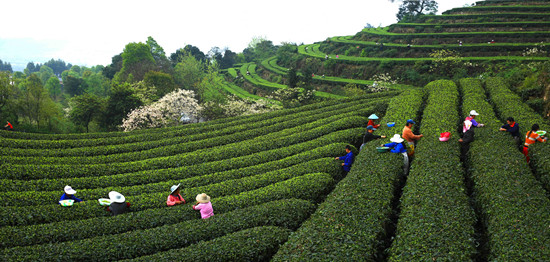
[389,80,475,261]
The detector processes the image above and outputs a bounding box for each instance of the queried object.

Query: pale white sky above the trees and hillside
[0,0,476,71]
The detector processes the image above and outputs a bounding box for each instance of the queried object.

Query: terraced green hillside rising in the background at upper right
[234,0,550,101]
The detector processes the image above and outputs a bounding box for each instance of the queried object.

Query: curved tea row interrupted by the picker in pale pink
[0,173,334,247]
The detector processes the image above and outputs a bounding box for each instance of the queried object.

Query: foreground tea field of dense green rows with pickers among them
[4,75,550,261]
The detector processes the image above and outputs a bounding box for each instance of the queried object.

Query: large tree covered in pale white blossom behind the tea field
[121,89,202,131]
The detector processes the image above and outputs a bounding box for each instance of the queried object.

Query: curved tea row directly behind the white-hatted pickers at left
[0,132,364,192]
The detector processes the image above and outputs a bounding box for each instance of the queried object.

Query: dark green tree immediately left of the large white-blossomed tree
[103,83,143,130]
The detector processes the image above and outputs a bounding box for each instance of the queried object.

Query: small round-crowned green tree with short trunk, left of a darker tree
[69,94,103,133]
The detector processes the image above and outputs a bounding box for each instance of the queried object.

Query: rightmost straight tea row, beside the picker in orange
[485,78,550,191]
